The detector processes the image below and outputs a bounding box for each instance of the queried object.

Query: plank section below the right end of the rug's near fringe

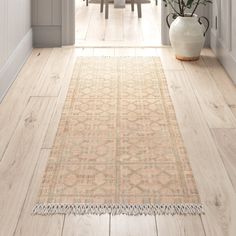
[156,216,205,236]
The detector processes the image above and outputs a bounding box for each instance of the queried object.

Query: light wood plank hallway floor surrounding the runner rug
[0,48,236,236]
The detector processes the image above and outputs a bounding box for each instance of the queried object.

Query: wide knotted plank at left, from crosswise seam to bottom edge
[0,97,56,236]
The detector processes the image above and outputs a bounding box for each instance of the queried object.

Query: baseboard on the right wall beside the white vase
[211,30,236,84]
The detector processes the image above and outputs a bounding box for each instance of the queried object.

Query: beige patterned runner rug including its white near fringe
[33,57,203,215]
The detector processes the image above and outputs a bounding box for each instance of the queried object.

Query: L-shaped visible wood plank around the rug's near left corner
[14,149,64,236]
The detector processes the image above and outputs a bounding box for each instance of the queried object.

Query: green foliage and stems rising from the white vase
[162,0,212,16]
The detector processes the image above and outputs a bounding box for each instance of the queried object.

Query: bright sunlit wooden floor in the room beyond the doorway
[76,0,161,47]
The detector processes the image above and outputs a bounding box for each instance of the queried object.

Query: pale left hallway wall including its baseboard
[0,0,32,101]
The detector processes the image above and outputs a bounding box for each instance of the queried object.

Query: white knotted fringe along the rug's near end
[33,203,204,216]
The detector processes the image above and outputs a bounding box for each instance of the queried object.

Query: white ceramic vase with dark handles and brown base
[167,15,209,61]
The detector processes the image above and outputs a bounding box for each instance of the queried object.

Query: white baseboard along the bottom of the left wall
[0,29,33,102]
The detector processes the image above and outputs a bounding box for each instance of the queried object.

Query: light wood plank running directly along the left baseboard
[0,49,52,160]
